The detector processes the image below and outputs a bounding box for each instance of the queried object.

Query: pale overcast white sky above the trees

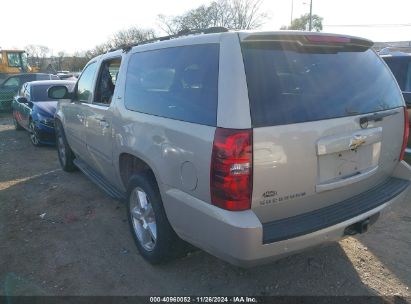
[0,0,411,55]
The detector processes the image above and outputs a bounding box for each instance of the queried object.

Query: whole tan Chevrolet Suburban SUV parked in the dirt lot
[49,28,411,266]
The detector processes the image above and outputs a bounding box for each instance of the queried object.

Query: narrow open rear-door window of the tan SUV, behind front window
[94,58,121,105]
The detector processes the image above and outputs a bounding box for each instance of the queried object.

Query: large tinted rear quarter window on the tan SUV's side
[125,44,219,126]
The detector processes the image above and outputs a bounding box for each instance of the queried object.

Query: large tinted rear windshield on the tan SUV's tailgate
[242,42,402,127]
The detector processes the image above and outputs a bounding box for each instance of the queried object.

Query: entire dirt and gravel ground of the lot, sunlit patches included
[0,115,411,297]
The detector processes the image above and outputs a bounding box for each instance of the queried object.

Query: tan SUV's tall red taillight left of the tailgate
[210,128,253,211]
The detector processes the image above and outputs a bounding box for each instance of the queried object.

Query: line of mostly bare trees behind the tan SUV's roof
[26,0,322,71]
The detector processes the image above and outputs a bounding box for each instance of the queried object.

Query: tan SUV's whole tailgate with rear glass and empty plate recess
[242,35,404,223]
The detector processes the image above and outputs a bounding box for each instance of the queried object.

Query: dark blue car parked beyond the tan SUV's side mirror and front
[12,80,76,146]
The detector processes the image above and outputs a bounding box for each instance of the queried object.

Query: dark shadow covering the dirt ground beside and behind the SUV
[0,171,374,295]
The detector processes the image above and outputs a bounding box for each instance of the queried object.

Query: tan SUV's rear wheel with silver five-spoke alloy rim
[127,172,188,264]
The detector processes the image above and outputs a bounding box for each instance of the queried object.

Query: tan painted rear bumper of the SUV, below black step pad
[164,162,409,267]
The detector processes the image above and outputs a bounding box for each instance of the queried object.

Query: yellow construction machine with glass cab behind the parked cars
[0,49,39,82]
